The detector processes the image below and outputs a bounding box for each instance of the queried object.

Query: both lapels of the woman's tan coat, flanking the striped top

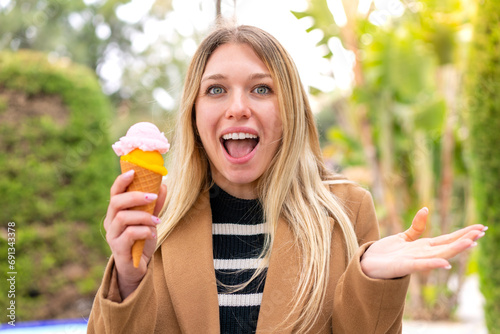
[161,192,300,334]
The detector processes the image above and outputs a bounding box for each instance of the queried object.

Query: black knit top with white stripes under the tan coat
[210,185,267,334]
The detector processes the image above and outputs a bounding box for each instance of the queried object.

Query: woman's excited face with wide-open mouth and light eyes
[195,43,282,199]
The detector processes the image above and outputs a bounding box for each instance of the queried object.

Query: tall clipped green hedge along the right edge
[468,1,500,334]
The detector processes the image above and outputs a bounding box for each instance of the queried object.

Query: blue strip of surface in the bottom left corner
[0,319,87,334]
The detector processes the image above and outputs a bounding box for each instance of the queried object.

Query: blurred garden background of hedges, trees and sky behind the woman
[0,0,500,333]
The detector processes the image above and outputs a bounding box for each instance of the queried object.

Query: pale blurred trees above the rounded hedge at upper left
[0,0,188,120]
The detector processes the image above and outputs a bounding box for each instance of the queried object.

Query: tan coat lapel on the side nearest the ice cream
[161,192,220,334]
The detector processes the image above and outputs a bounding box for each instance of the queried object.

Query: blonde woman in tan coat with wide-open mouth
[88,26,486,334]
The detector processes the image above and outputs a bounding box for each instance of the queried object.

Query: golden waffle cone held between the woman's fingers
[120,160,162,268]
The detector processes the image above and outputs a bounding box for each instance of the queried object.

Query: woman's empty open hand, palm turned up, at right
[361,208,487,279]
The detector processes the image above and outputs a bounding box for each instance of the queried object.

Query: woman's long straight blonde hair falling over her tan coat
[158,26,358,332]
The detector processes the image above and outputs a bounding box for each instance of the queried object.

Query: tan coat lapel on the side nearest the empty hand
[257,219,302,333]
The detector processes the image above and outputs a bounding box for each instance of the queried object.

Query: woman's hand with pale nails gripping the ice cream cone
[104,170,167,299]
